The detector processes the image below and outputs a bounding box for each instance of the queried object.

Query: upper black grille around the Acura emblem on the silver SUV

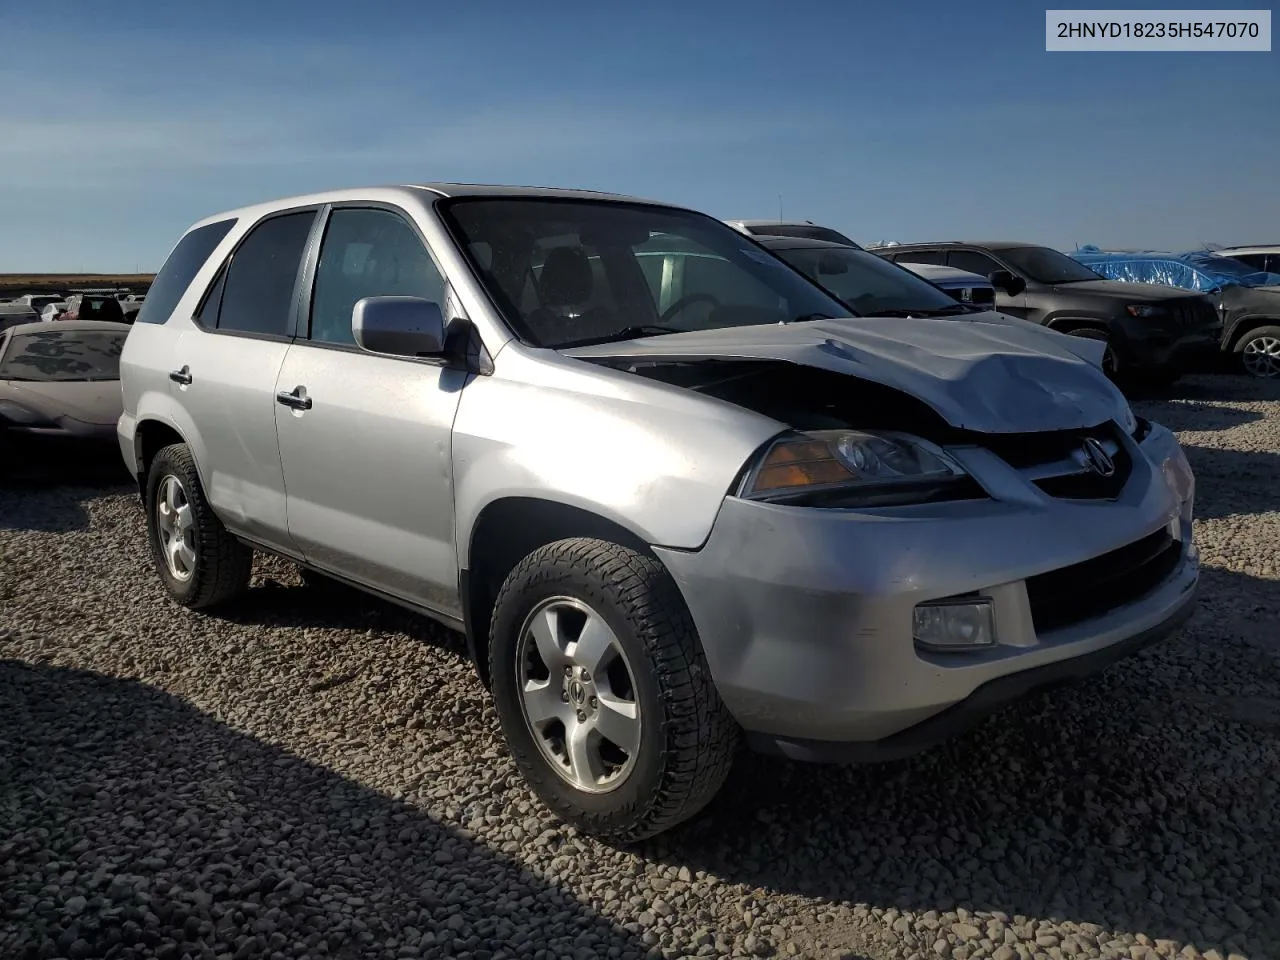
[982,424,1133,500]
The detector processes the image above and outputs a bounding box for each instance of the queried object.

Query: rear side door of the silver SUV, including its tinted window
[170,207,317,553]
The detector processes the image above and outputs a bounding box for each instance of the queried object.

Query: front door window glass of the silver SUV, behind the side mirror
[311,209,444,344]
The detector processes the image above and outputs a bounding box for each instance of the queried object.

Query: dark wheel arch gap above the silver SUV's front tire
[458,497,660,687]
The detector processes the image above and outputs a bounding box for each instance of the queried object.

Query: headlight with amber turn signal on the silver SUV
[740,430,968,506]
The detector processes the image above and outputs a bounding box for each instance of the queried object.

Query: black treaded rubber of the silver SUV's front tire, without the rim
[489,539,739,842]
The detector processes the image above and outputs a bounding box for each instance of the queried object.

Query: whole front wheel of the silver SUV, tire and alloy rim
[489,539,737,842]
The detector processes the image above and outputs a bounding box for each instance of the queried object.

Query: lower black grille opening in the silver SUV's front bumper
[1027,527,1183,634]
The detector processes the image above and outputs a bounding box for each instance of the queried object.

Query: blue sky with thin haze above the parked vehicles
[0,0,1280,273]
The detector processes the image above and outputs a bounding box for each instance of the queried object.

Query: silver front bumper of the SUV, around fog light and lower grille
[658,425,1199,759]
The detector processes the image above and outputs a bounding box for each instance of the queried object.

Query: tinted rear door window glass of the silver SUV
[211,210,316,337]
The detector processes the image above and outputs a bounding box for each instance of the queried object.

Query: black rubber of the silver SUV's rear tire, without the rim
[146,443,253,609]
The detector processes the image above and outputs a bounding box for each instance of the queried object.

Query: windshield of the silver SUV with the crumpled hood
[442,197,849,347]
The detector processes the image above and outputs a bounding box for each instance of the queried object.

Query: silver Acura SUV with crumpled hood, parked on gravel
[119,184,1198,840]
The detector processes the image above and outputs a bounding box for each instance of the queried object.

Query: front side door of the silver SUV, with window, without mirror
[275,205,468,616]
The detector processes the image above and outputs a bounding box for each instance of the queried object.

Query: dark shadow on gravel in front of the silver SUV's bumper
[646,568,1280,960]
